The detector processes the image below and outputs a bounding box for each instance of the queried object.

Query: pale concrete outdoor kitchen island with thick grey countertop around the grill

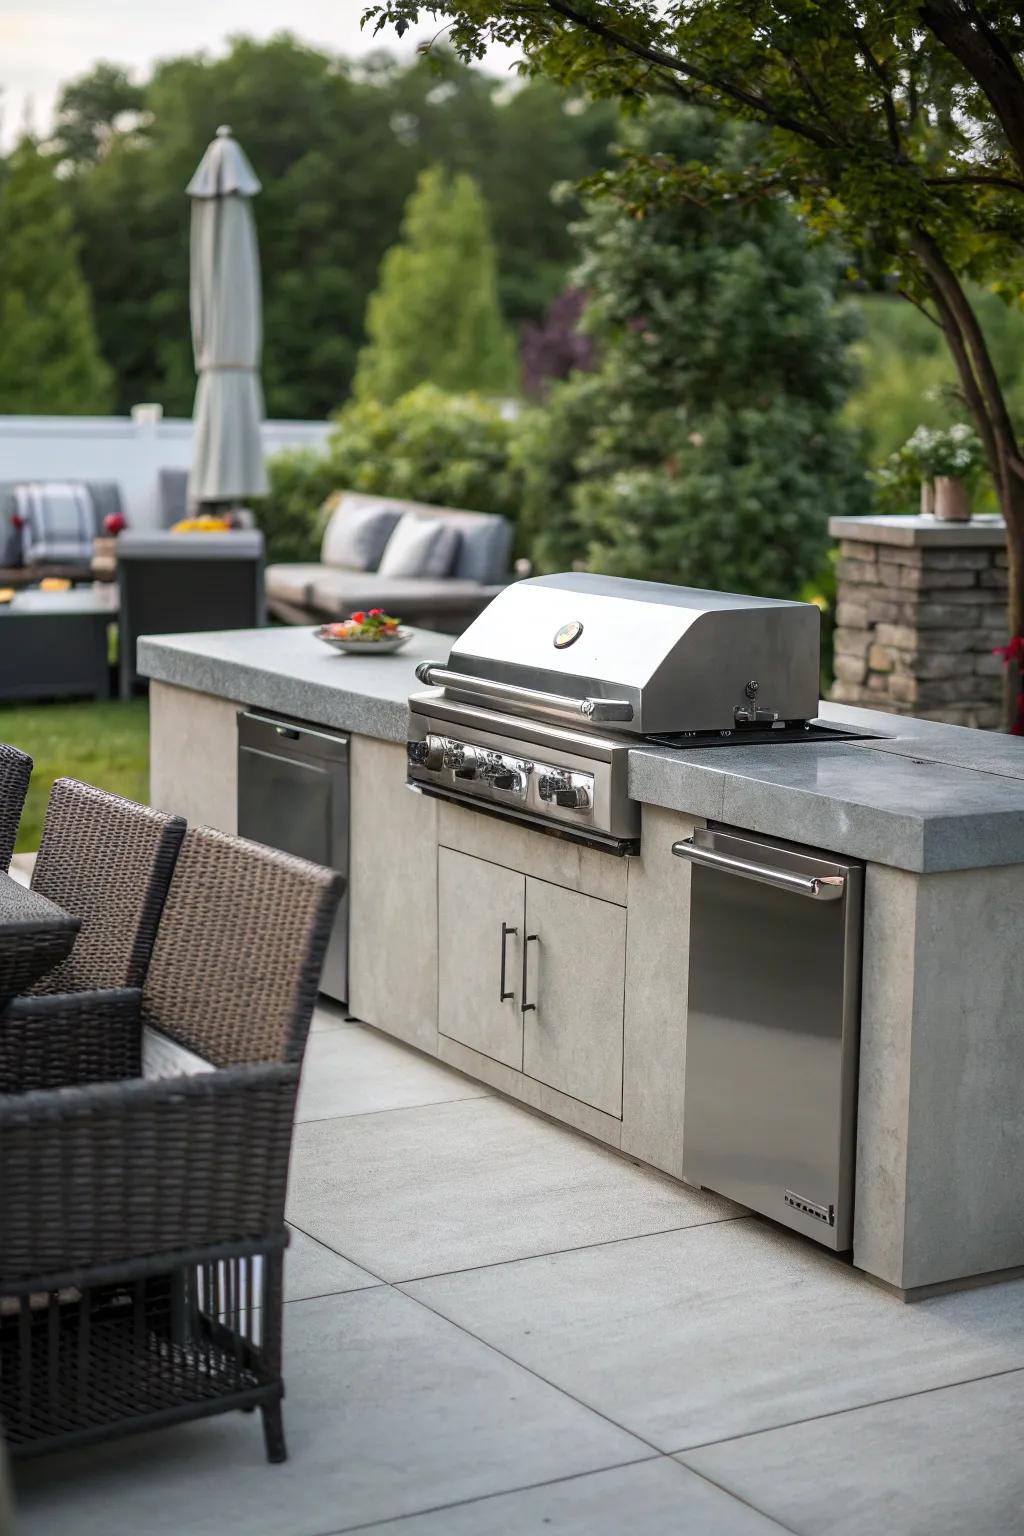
[138,628,1024,1295]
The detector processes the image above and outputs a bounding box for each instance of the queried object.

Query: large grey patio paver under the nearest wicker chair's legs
[17,1287,651,1536]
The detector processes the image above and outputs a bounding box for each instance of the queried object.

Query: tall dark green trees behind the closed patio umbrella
[49,34,613,418]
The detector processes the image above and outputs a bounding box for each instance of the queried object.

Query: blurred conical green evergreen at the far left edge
[0,138,111,416]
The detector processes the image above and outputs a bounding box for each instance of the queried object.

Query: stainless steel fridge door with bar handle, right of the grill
[672,828,863,1250]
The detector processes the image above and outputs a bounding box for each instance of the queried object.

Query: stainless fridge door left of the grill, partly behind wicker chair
[238,714,348,1003]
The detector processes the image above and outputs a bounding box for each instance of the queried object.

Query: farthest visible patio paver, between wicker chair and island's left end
[296,1023,488,1120]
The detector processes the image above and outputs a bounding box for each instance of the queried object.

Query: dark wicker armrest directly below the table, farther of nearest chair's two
[0,988,143,1094]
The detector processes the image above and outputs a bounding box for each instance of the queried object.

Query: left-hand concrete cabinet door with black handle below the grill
[438,848,527,1072]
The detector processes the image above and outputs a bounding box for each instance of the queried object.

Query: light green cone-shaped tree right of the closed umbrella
[355,166,516,404]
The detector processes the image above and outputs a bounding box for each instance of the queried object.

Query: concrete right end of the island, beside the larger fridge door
[854,865,1024,1290]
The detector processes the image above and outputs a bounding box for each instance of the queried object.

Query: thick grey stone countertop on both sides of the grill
[138,628,1024,872]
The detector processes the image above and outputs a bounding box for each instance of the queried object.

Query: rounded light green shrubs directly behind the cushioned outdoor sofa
[258,384,520,561]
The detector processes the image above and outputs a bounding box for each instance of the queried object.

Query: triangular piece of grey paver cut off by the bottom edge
[356,1458,783,1536]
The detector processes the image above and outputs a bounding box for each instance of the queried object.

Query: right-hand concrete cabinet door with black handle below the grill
[524,879,626,1115]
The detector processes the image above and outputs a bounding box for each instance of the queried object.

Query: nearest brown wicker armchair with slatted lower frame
[0,828,342,1461]
